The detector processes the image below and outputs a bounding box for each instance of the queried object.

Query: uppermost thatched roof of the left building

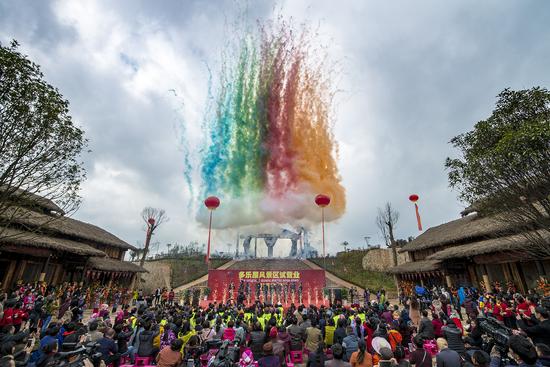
[0,207,135,250]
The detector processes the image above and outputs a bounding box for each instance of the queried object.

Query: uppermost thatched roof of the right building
[399,214,513,252]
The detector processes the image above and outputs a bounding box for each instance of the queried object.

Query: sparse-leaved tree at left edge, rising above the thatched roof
[0,41,87,238]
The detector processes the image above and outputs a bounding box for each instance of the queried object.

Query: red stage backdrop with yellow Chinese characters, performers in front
[208,269,326,305]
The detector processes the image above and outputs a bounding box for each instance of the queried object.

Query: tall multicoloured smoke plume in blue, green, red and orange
[197,21,346,228]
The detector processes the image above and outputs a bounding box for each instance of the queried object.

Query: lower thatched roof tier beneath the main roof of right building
[428,232,550,261]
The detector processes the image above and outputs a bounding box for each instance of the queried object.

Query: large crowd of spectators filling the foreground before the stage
[0,284,550,367]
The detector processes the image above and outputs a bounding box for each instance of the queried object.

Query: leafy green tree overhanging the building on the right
[445,87,550,256]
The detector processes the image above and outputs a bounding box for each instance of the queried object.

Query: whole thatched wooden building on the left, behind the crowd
[0,190,145,290]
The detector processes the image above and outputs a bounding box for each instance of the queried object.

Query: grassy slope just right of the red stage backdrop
[308,250,395,291]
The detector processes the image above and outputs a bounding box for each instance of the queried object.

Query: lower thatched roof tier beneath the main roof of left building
[0,228,105,256]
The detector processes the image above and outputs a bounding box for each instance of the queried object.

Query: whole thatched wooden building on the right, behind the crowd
[389,207,550,291]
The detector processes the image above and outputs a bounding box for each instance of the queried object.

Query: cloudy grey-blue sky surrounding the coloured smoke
[0,0,550,258]
